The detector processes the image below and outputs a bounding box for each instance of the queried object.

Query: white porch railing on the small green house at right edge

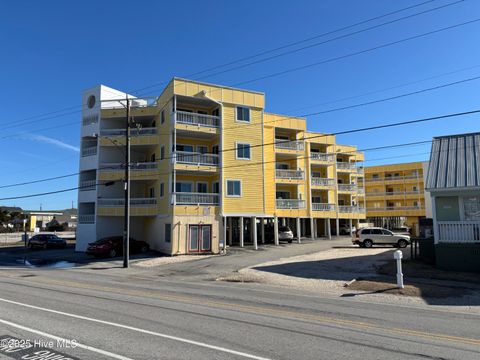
[435,221,480,243]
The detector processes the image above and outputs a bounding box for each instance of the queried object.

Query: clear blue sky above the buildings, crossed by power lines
[0,0,480,209]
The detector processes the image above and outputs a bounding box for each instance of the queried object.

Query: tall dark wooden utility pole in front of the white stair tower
[123,95,130,268]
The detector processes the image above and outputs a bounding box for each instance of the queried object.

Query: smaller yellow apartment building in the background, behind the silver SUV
[364,162,431,235]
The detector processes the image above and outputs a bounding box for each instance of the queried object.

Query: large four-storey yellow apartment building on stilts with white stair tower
[76,78,365,255]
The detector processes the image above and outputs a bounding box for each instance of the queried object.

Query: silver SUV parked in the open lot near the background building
[352,227,410,248]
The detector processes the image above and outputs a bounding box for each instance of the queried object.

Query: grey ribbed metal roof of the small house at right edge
[425,133,480,190]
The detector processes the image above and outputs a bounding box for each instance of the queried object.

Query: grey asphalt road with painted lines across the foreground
[0,245,480,360]
